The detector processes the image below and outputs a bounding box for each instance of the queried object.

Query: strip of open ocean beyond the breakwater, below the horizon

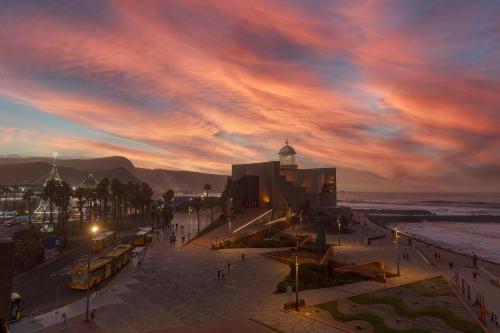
[337,192,500,216]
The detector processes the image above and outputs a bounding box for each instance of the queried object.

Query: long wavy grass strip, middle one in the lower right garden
[349,294,483,333]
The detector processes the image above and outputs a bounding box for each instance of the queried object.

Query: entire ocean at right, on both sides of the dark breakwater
[338,192,500,264]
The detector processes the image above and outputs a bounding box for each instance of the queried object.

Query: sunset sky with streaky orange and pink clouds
[0,0,500,192]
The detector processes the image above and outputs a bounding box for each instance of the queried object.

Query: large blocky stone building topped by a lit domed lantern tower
[231,141,337,216]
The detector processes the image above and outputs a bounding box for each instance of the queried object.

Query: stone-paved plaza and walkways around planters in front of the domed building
[12,211,496,333]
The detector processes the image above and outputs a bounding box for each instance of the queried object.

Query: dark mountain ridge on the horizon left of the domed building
[0,156,227,194]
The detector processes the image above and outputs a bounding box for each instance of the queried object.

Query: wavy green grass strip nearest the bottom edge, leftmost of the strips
[316,301,432,333]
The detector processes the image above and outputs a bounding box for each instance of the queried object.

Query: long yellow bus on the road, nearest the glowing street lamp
[69,244,132,290]
